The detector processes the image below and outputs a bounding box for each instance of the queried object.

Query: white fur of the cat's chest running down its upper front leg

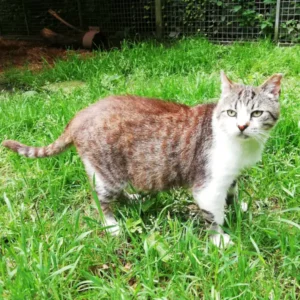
[193,126,262,224]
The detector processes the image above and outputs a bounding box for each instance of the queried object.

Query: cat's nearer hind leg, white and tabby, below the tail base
[82,158,124,235]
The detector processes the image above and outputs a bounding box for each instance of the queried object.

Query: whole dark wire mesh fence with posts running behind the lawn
[0,0,300,43]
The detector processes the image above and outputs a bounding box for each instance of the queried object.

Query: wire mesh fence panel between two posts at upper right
[163,0,275,41]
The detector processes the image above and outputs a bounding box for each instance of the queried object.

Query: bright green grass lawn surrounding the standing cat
[0,39,300,299]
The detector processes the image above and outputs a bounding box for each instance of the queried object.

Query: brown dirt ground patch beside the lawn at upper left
[0,38,91,73]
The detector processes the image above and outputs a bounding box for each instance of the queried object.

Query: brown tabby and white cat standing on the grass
[3,71,282,247]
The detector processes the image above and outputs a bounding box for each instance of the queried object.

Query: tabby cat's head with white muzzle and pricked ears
[215,71,282,142]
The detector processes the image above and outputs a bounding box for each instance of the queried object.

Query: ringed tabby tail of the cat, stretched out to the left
[2,130,73,158]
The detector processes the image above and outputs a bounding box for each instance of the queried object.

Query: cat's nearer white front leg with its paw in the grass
[193,182,233,248]
